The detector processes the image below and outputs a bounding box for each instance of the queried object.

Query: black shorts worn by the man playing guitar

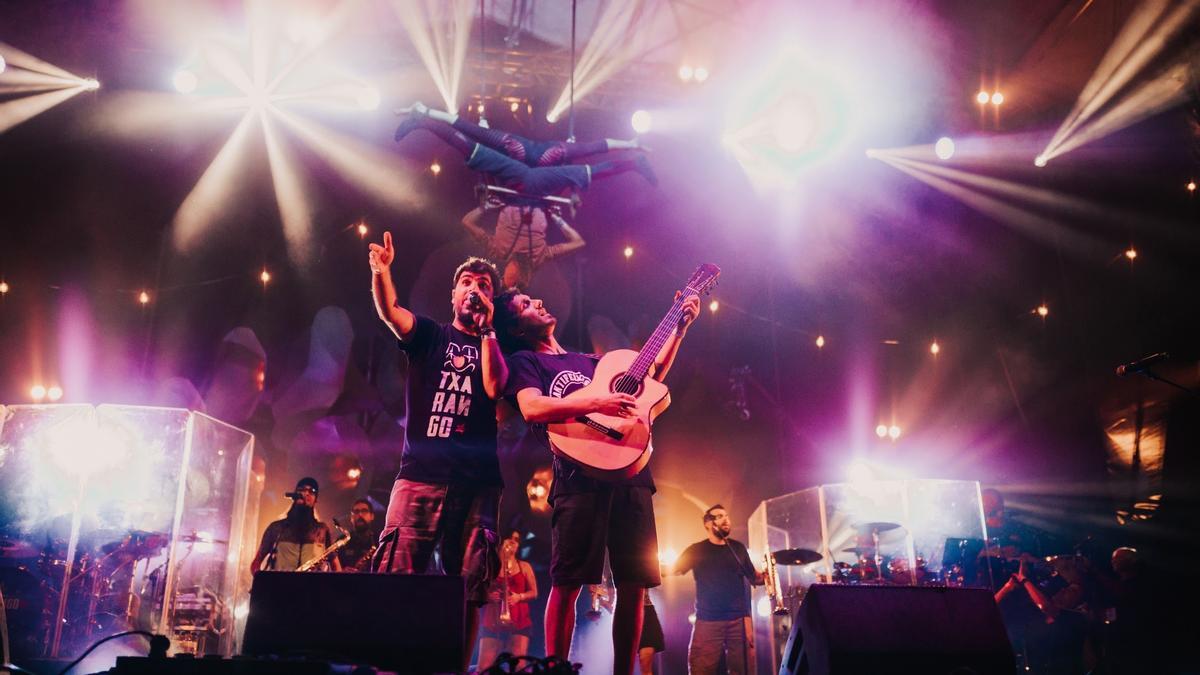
[550,485,662,589]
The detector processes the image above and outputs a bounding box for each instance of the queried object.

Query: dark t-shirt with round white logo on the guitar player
[504,351,654,504]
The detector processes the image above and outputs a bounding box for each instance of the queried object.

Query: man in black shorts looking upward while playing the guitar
[494,283,700,675]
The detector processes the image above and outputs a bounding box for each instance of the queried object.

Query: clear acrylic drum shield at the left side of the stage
[0,405,257,658]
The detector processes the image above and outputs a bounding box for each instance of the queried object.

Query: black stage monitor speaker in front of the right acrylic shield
[779,584,1016,675]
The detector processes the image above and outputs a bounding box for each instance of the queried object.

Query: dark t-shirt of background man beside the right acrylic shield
[674,539,755,621]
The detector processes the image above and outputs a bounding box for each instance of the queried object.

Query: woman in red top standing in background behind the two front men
[478,528,538,671]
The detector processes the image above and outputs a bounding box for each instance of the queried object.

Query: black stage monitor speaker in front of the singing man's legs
[242,572,466,673]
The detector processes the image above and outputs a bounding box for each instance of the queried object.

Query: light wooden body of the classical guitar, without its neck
[546,350,671,480]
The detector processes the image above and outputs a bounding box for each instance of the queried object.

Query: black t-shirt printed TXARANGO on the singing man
[397,316,503,486]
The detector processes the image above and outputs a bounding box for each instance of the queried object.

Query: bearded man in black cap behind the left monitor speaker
[250,478,342,574]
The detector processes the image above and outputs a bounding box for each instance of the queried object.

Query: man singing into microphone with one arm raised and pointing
[368,232,508,671]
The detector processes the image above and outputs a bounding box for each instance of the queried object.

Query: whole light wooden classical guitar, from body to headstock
[546,264,721,480]
